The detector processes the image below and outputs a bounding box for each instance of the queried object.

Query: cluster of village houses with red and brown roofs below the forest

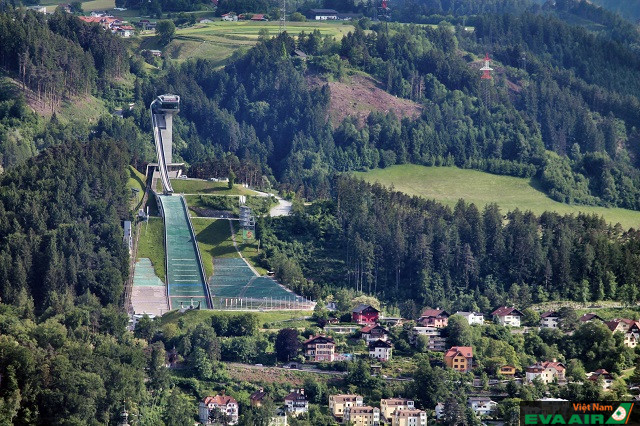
[189,304,640,426]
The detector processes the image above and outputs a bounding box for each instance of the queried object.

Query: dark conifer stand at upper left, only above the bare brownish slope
[0,9,128,107]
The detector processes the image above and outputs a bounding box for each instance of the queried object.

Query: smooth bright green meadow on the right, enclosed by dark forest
[355,164,640,229]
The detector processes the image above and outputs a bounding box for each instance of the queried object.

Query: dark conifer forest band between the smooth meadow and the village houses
[259,177,640,317]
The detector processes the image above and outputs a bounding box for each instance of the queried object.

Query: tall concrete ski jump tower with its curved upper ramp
[151,95,181,194]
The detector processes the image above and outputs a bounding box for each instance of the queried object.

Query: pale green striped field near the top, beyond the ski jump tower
[147,21,354,65]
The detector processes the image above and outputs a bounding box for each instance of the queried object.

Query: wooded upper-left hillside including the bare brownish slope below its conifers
[0,10,129,168]
